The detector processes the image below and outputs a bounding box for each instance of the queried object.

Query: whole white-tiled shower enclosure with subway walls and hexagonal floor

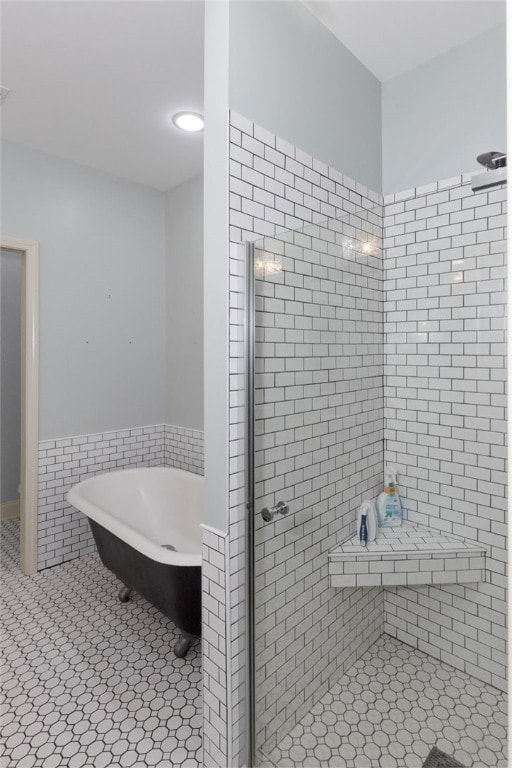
[201,112,506,766]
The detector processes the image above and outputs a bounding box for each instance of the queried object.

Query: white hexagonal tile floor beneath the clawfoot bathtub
[0,520,202,768]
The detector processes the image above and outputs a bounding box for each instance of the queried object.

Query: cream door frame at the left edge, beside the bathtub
[0,235,39,576]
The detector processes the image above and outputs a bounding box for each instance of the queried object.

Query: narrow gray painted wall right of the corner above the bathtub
[166,176,204,429]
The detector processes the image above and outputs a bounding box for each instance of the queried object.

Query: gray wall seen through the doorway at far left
[0,249,21,501]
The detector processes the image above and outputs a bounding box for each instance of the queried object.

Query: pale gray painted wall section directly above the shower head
[382,25,506,193]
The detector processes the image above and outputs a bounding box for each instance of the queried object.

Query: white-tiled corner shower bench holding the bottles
[329,521,486,587]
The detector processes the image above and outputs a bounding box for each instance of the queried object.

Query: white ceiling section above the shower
[304,0,506,82]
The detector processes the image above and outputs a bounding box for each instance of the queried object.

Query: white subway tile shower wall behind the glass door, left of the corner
[226,113,383,765]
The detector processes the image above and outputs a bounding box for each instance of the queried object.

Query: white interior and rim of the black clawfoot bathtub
[66,467,204,566]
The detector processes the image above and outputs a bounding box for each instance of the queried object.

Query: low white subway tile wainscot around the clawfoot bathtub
[38,424,203,570]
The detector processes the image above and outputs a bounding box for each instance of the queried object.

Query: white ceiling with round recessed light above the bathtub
[1,0,204,190]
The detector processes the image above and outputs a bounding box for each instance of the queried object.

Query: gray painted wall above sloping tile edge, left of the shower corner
[229,0,382,192]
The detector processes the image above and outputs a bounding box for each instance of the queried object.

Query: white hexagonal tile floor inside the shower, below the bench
[269,635,508,768]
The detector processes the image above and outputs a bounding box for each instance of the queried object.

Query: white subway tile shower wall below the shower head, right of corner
[384,175,507,690]
